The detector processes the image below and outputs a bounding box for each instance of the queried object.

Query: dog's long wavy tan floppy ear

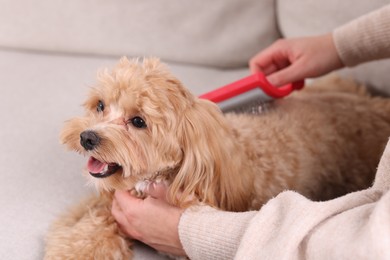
[169,99,250,211]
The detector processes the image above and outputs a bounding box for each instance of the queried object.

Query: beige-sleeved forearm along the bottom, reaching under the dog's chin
[179,189,390,260]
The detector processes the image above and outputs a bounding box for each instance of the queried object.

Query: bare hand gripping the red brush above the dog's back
[249,34,344,86]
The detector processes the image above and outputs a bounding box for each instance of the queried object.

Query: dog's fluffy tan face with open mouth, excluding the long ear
[61,59,194,190]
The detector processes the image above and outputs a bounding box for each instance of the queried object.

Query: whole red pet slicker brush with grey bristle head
[199,72,304,112]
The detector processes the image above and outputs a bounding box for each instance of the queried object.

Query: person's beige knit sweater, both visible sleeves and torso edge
[179,6,390,260]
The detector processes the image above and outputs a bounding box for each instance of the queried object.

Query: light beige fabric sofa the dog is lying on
[0,0,390,260]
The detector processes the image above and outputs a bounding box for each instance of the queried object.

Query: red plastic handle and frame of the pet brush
[200,72,304,103]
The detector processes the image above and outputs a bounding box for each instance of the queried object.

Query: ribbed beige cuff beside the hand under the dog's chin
[179,206,256,260]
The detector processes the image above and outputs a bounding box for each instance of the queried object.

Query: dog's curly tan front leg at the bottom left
[45,196,132,259]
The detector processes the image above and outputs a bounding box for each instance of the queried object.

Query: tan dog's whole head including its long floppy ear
[61,58,250,209]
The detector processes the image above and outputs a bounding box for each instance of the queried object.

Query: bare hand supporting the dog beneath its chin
[111,183,186,256]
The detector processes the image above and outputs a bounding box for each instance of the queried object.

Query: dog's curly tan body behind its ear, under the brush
[226,78,390,208]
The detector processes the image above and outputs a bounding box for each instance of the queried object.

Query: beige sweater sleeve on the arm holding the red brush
[333,5,390,67]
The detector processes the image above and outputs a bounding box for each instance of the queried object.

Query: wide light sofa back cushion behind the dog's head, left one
[0,0,278,68]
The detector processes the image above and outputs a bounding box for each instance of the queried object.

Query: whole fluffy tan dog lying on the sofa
[45,58,390,259]
